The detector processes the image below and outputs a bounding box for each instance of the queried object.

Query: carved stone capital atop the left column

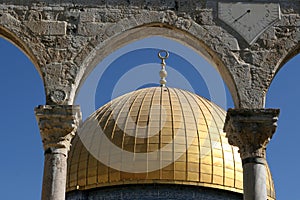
[35,105,81,152]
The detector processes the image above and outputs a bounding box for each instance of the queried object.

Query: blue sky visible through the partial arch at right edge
[266,49,300,199]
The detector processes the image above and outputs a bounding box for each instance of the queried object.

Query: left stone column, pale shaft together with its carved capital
[35,105,81,200]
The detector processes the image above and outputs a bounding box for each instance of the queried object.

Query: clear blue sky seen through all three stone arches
[0,38,300,200]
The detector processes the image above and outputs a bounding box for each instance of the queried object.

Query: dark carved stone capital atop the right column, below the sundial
[224,109,279,160]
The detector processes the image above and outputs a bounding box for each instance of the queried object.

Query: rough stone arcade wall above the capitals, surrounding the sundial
[0,0,300,108]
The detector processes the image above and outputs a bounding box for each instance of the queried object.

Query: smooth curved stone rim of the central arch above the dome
[70,23,239,108]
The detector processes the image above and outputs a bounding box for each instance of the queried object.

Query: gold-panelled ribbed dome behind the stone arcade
[67,87,275,199]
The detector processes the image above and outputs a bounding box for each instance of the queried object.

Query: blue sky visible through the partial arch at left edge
[0,36,45,199]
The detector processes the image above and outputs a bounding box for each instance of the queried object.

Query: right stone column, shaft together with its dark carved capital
[224,109,279,200]
